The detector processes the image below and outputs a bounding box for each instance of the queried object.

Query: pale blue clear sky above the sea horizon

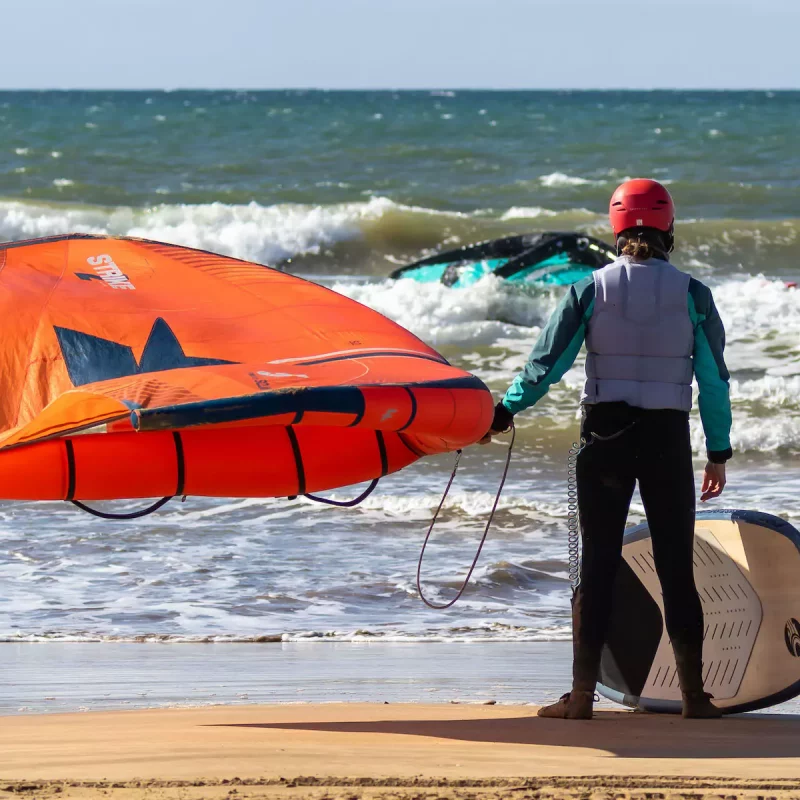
[0,0,800,89]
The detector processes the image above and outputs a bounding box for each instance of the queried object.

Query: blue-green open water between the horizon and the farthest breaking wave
[0,92,800,219]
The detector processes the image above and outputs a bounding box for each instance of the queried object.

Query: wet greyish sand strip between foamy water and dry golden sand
[6,640,800,720]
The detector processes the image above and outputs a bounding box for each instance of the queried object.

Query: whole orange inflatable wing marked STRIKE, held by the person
[0,235,492,500]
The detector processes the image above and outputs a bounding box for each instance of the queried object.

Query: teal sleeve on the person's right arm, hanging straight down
[689,278,733,463]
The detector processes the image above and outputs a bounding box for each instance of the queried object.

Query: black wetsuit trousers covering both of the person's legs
[572,403,703,691]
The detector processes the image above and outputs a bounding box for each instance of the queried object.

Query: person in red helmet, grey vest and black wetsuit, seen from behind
[482,179,732,719]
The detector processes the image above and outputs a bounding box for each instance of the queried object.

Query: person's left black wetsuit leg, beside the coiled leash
[572,403,636,691]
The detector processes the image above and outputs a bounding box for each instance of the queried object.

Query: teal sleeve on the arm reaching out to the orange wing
[503,276,594,414]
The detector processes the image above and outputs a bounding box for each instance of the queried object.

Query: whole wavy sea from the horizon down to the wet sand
[0,91,800,643]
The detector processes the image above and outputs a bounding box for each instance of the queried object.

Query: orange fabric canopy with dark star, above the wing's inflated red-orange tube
[0,235,488,449]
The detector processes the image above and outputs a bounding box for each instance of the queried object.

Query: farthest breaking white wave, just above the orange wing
[0,197,800,274]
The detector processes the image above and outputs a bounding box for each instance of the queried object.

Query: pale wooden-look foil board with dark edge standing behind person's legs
[598,510,800,714]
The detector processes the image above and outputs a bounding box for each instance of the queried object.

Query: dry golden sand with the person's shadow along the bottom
[0,704,800,800]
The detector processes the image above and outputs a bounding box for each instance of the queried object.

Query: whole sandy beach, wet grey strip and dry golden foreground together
[0,642,800,800]
